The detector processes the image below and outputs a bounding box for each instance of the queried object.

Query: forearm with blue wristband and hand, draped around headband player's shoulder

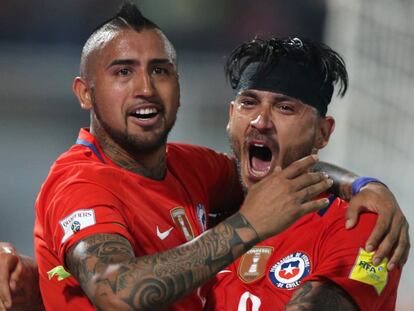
[315,162,410,271]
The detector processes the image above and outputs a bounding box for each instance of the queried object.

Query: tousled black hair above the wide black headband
[224,37,348,97]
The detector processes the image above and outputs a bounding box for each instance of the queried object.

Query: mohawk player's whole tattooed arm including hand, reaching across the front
[65,157,332,310]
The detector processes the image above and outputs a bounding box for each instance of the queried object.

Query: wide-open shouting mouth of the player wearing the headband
[248,142,273,178]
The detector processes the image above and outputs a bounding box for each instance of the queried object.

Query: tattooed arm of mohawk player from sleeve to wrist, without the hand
[66,213,259,310]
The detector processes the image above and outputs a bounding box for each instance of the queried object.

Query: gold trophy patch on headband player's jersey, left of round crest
[237,246,273,283]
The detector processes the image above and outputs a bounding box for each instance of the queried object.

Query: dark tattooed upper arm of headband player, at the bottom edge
[285,281,359,311]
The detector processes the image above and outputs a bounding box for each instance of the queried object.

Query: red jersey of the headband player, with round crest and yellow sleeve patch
[206,198,401,311]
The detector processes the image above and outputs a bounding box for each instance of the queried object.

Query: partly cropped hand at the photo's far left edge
[0,242,23,311]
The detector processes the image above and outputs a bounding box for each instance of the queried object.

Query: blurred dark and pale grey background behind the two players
[0,0,414,310]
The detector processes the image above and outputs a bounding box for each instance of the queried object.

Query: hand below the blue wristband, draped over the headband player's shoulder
[346,183,410,271]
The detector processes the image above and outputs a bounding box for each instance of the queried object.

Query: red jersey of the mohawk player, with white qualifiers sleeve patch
[34,129,237,311]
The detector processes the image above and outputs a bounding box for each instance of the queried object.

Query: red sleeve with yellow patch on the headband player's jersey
[307,206,401,310]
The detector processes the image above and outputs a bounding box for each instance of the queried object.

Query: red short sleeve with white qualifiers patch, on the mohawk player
[45,182,134,264]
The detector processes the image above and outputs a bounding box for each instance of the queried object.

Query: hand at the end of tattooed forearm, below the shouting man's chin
[240,155,332,240]
